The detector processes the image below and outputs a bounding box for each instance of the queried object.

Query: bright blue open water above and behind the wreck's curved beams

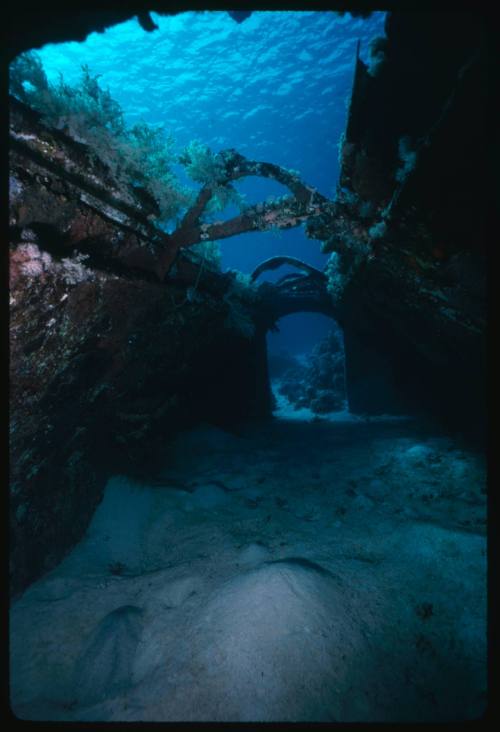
[36,11,385,352]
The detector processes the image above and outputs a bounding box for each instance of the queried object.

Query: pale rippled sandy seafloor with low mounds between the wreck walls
[10,384,486,722]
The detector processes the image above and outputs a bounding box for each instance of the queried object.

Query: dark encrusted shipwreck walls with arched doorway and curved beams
[9,12,491,720]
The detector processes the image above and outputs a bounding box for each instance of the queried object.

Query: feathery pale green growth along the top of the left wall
[9,51,243,227]
